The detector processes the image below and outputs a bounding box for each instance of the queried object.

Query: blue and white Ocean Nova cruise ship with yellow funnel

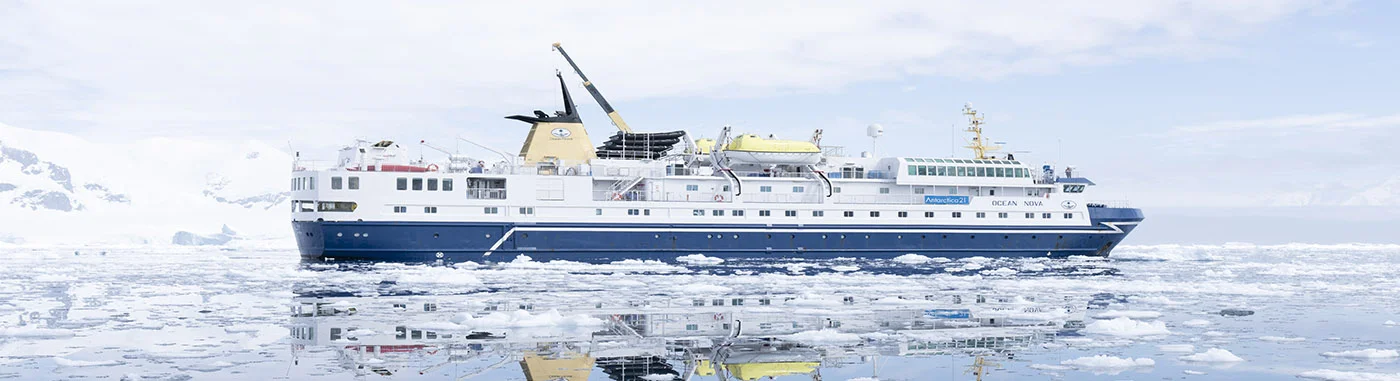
[290,43,1142,262]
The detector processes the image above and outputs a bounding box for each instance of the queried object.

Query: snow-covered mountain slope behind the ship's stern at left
[0,125,291,244]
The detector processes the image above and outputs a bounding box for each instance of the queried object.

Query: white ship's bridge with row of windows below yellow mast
[896,157,1037,185]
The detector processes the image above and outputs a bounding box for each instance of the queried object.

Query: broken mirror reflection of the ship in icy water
[281,288,1069,381]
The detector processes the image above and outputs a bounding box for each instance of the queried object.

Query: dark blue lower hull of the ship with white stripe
[293,207,1142,262]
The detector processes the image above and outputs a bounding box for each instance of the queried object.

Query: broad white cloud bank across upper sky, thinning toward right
[0,0,1324,141]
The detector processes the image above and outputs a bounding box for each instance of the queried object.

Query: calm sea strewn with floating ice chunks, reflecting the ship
[0,245,1400,380]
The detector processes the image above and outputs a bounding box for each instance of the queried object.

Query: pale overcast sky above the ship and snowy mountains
[0,0,1400,206]
